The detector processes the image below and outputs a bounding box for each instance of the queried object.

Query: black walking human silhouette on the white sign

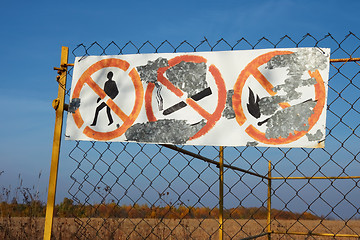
[90,72,119,126]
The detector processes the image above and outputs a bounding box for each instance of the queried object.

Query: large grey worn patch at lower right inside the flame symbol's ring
[265,99,316,139]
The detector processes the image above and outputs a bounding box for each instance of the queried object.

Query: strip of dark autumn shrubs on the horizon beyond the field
[0,198,320,220]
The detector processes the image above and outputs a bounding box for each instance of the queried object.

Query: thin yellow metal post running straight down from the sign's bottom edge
[219,147,224,240]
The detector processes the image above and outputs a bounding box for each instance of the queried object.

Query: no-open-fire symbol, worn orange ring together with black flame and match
[232,50,326,145]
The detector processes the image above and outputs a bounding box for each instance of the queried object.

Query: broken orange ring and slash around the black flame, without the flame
[232,51,325,145]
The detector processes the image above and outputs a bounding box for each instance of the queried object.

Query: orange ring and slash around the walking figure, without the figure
[72,58,144,141]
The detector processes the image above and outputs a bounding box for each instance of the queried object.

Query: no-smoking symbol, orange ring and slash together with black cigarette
[145,55,226,140]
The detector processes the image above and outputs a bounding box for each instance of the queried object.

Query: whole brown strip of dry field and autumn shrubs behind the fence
[0,198,360,240]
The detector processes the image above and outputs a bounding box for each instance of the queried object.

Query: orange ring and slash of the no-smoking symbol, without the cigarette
[145,55,226,140]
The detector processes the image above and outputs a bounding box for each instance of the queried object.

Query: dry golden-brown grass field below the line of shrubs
[0,217,360,240]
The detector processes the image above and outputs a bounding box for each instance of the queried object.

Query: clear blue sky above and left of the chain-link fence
[0,0,360,217]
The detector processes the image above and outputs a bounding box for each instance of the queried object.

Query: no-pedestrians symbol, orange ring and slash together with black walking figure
[72,58,144,141]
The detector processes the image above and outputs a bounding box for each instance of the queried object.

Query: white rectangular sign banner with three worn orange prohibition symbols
[65,48,330,148]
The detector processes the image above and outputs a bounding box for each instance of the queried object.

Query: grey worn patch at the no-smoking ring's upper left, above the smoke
[136,57,169,83]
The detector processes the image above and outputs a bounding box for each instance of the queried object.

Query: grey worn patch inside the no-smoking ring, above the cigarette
[165,61,208,96]
